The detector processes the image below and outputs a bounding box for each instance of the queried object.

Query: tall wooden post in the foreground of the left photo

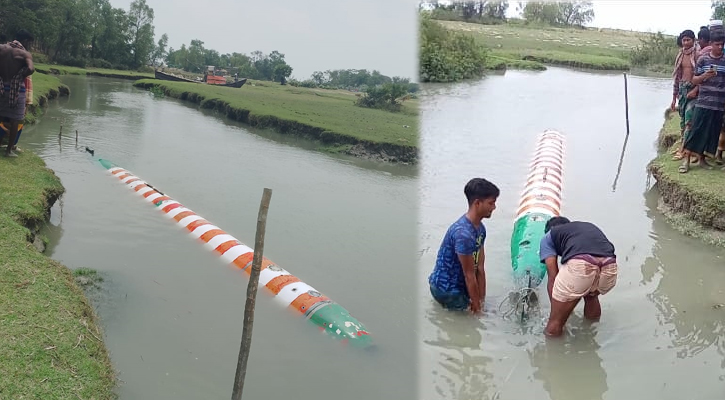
[232,188,272,400]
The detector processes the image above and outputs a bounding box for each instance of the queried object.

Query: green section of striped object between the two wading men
[511,213,551,288]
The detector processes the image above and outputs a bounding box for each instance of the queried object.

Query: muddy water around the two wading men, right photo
[418,68,725,400]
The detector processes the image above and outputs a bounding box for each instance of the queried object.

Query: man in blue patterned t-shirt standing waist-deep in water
[428,178,500,314]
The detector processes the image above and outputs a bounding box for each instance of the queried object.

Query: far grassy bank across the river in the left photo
[134,79,418,163]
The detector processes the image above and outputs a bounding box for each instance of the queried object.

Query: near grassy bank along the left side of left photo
[0,73,117,399]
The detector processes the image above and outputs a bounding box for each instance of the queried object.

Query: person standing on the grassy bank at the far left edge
[0,38,35,157]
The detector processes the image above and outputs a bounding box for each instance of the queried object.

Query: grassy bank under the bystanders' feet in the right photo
[648,112,725,246]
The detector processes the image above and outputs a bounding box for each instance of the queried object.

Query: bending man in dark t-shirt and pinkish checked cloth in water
[539,217,617,336]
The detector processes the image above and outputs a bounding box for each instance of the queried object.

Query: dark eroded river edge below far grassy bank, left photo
[134,79,418,165]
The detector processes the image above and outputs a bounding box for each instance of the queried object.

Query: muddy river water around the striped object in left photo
[21,77,417,399]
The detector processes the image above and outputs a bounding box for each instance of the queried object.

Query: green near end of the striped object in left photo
[309,303,372,347]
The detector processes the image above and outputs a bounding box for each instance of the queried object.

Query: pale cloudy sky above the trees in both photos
[111,0,710,79]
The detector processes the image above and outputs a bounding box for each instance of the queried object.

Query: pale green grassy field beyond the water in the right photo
[437,21,662,71]
